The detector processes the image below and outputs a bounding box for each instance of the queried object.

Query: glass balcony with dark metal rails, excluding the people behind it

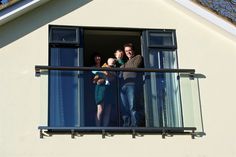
[35,66,205,138]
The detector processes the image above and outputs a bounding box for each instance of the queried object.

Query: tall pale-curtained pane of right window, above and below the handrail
[145,48,182,127]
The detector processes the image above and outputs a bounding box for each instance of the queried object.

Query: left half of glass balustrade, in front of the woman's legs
[40,70,121,127]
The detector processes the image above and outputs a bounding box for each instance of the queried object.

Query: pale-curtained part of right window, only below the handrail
[145,72,183,127]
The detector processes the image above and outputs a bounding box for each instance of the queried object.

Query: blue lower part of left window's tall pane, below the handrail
[49,70,79,127]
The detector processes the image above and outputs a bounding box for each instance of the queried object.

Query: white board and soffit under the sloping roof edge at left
[0,0,49,25]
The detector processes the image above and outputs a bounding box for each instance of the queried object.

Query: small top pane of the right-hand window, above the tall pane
[148,32,175,46]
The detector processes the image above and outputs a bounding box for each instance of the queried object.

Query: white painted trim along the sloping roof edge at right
[175,0,236,36]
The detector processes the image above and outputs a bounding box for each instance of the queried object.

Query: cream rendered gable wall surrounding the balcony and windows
[0,0,236,157]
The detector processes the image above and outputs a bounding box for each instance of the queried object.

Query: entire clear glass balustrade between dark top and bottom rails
[37,69,203,132]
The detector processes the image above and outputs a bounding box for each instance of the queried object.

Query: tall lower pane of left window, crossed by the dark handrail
[49,48,79,126]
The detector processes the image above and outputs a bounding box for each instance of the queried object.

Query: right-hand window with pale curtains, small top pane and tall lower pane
[144,30,183,127]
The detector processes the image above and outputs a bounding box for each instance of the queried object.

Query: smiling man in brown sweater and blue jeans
[121,43,144,127]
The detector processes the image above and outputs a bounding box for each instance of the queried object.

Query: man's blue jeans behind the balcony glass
[120,84,138,127]
